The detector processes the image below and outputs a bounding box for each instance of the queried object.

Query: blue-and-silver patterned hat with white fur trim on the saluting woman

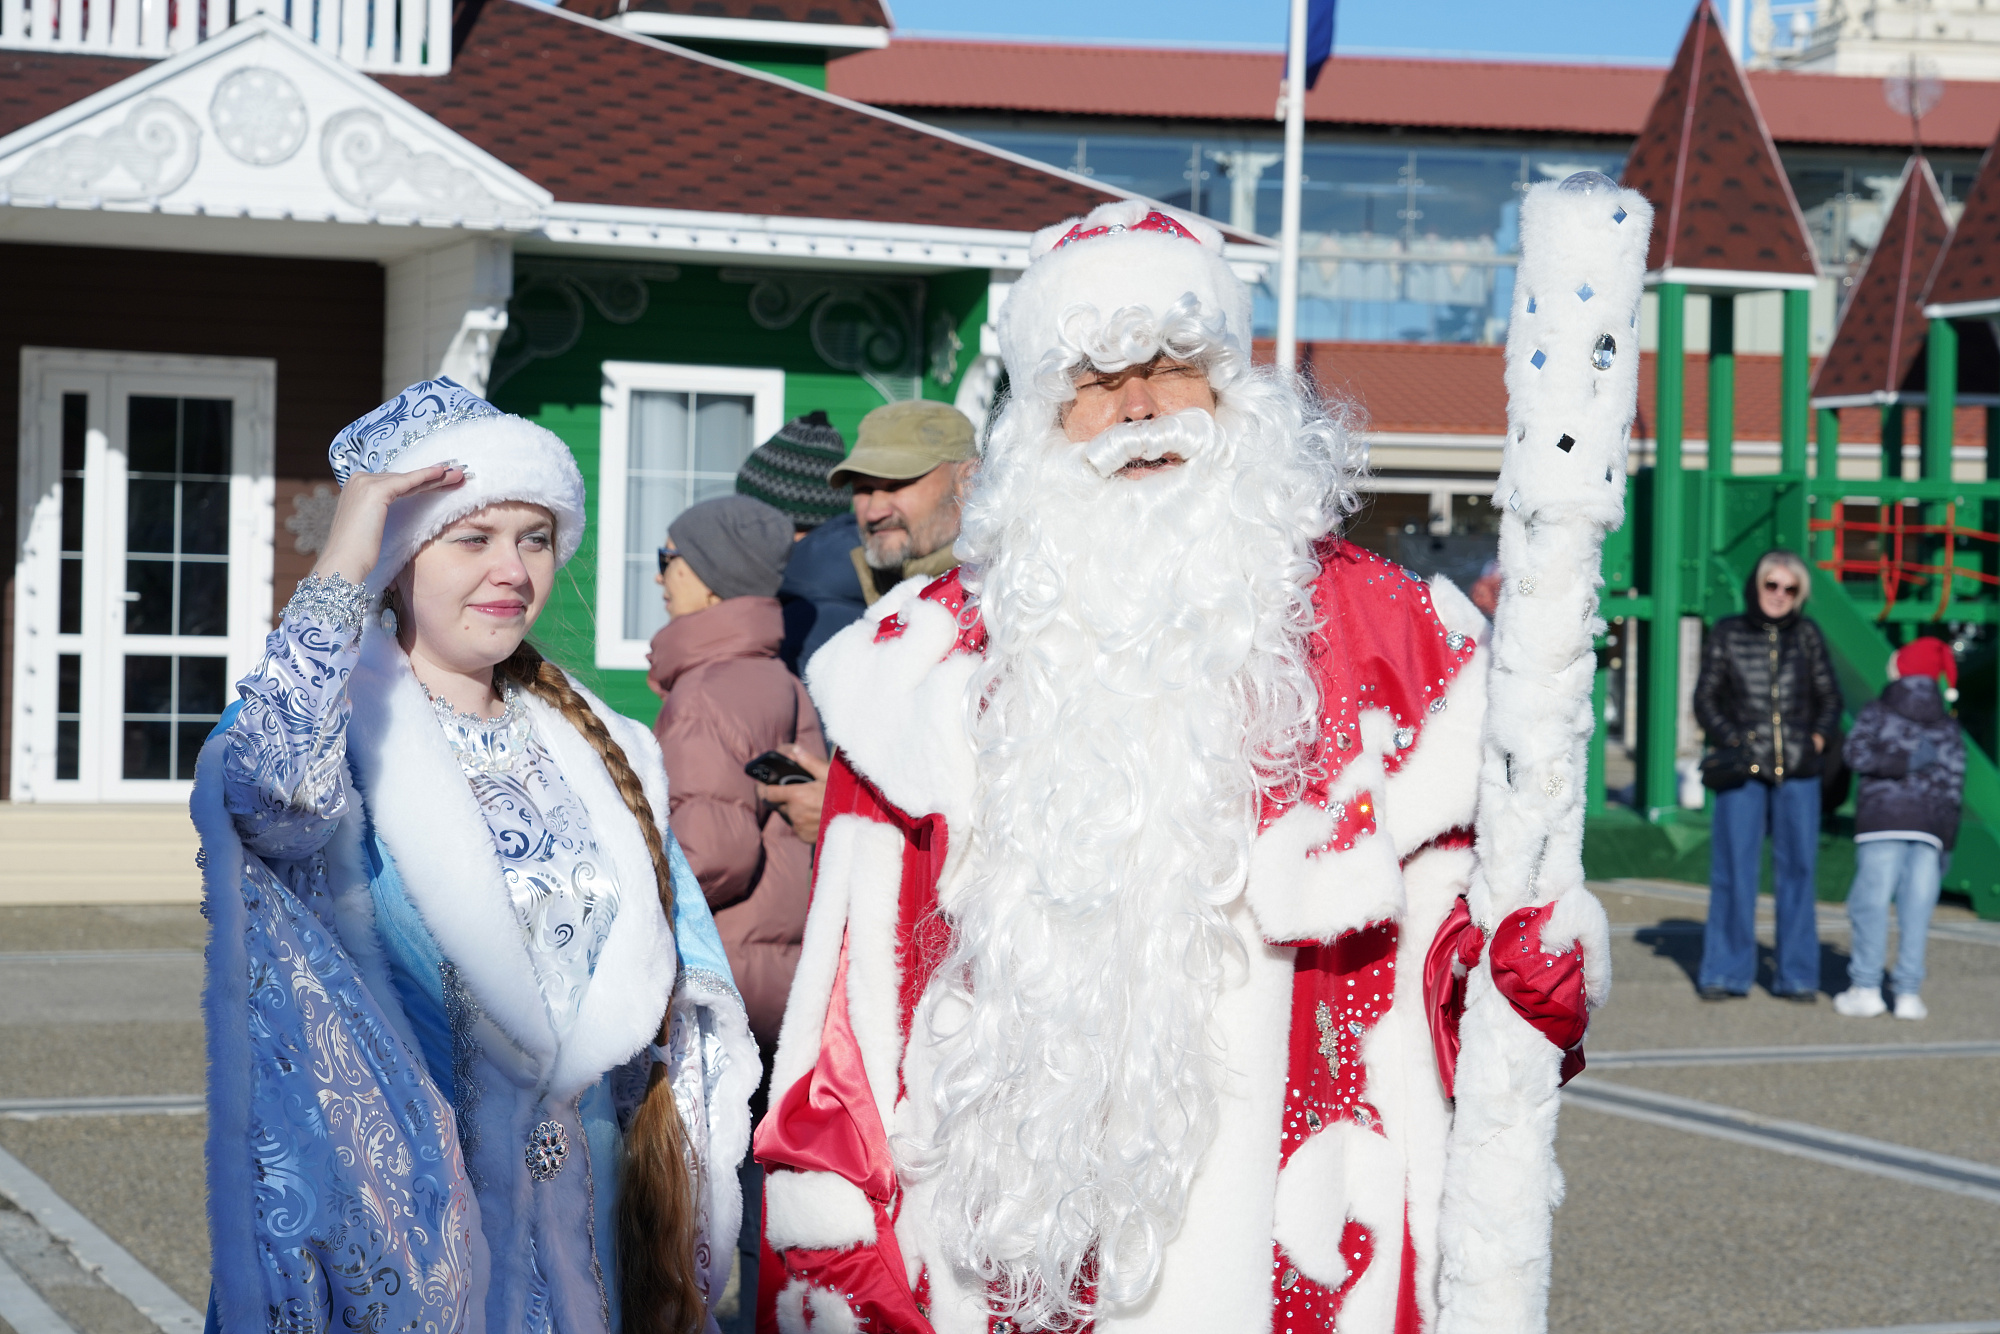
[326,378,584,594]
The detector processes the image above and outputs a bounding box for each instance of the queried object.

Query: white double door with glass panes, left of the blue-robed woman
[12,348,276,802]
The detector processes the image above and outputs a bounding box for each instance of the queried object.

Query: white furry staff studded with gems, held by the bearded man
[1438,172,1652,1334]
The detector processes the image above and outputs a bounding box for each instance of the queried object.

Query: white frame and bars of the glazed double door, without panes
[10,346,278,802]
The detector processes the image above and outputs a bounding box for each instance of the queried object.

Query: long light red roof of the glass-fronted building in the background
[826,38,2000,148]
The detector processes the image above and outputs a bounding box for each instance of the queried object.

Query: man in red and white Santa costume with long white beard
[756,202,1586,1334]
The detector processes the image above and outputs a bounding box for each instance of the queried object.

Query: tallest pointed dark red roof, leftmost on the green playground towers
[1624,0,1820,274]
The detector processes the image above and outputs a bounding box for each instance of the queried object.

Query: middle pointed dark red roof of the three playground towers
[1812,158,1952,398]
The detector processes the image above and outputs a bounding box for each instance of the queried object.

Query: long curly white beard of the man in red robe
[904,374,1350,1330]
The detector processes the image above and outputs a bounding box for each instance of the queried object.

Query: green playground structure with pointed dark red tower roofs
[1584,0,2000,920]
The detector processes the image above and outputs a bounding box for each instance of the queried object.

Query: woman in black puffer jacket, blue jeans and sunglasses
[1694,550,1840,1002]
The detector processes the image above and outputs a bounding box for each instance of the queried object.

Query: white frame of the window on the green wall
[596,362,784,672]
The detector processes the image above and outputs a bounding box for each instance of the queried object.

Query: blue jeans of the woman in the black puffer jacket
[1696,778,1820,996]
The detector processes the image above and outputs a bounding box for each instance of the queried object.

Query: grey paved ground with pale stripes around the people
[0,882,2000,1334]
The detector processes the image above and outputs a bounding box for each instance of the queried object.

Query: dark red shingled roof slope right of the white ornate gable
[378,0,1118,232]
